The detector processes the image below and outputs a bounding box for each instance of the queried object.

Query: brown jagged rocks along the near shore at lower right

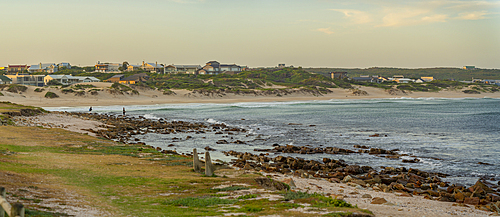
[224,150,500,212]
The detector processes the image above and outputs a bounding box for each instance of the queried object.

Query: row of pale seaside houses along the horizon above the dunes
[0,61,500,87]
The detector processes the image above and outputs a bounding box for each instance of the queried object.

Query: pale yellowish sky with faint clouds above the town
[0,0,500,68]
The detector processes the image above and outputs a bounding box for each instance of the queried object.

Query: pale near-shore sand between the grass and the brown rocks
[16,113,495,217]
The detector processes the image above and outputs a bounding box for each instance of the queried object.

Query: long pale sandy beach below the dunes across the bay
[0,82,500,107]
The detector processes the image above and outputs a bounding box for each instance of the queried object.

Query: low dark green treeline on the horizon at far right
[304,67,500,81]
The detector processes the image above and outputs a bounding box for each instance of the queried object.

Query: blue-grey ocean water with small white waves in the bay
[45,98,500,185]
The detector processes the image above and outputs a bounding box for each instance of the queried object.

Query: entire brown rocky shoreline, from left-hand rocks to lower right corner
[10,112,500,213]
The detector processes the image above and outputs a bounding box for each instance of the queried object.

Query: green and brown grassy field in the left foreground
[0,103,369,216]
